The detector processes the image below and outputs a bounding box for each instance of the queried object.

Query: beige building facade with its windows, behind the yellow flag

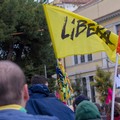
[63,0,120,102]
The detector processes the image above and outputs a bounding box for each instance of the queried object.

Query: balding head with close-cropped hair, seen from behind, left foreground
[0,61,25,106]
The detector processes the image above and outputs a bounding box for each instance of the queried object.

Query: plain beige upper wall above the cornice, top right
[74,0,120,20]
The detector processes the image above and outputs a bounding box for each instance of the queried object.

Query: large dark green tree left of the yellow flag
[0,0,56,78]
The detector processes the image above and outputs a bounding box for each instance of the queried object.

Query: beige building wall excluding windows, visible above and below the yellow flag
[65,0,120,102]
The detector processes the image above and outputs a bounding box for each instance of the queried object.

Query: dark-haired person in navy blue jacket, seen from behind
[26,75,75,120]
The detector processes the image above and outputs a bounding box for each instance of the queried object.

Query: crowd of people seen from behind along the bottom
[0,61,120,120]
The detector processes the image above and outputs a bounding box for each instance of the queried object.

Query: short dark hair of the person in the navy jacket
[31,74,48,84]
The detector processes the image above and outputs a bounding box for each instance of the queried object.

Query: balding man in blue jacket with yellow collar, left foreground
[0,61,58,120]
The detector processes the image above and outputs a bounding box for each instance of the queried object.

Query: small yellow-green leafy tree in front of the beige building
[91,67,112,103]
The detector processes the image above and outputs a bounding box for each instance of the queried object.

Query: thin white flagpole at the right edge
[111,53,118,120]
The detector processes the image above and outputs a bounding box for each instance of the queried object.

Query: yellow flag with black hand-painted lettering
[43,5,118,61]
